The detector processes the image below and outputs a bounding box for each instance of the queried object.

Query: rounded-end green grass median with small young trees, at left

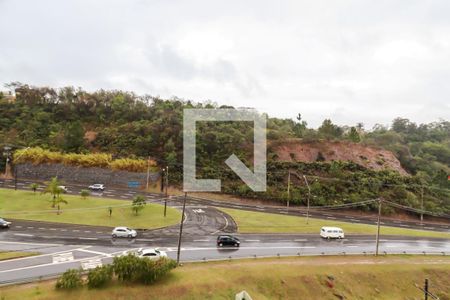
[0,189,181,229]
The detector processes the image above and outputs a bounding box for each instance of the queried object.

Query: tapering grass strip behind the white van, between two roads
[219,208,450,239]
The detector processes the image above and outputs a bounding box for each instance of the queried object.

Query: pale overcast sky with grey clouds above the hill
[0,0,450,128]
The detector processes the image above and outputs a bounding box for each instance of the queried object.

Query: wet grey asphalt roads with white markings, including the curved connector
[0,181,450,284]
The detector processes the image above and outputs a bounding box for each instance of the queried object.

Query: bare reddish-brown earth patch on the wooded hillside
[270,140,408,175]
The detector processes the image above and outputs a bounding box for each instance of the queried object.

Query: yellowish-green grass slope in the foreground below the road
[0,256,450,300]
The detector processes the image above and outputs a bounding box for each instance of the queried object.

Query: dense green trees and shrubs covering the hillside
[0,83,450,212]
